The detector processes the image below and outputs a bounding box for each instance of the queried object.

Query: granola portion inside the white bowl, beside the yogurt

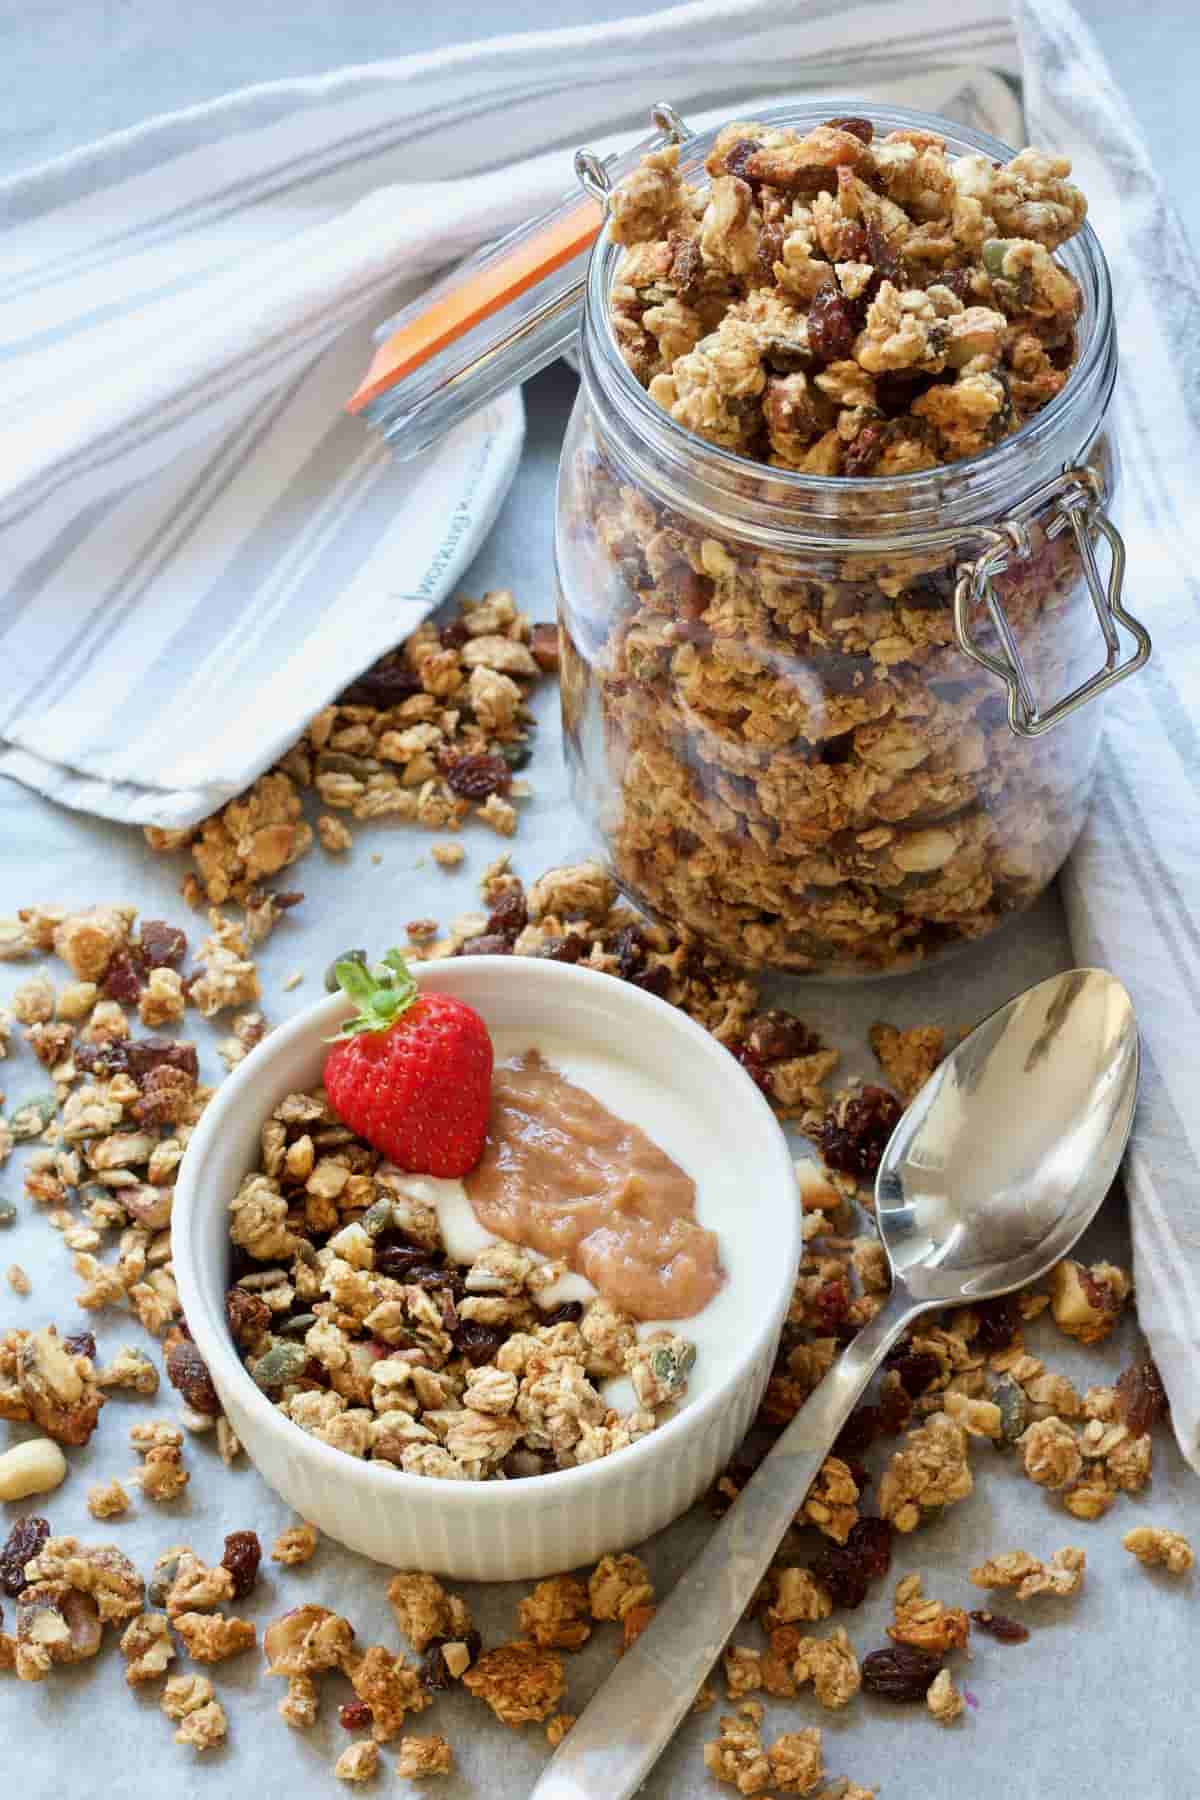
[227,1089,694,1481]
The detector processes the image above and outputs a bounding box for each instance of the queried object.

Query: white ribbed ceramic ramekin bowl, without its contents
[171,956,801,1580]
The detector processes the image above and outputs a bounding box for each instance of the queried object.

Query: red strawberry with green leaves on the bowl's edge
[326,950,491,1175]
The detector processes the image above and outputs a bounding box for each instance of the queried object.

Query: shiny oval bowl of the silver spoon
[874,968,1139,1305]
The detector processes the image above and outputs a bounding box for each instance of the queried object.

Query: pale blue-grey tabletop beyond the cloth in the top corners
[0,0,1200,261]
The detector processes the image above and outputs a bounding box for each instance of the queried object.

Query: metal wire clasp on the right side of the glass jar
[954,468,1151,738]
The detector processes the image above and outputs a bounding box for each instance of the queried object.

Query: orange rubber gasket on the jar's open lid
[345,200,604,412]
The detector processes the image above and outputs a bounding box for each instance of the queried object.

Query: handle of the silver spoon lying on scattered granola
[531,1283,925,1800]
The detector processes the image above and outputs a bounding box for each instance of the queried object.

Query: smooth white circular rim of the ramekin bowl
[171,956,801,1507]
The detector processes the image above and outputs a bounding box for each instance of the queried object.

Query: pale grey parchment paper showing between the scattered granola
[0,365,1200,1800]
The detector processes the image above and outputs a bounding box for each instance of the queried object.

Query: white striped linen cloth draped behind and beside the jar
[0,0,1200,1467]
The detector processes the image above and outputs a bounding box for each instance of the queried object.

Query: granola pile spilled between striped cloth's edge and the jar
[146,589,558,907]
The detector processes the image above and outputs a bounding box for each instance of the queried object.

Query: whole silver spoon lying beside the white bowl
[531,968,1139,1800]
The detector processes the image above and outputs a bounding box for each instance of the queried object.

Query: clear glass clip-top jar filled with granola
[556,106,1150,977]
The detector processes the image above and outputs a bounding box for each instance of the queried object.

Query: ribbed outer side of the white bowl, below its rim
[218,1343,775,1580]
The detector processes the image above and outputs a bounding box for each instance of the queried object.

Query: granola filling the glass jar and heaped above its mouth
[561,121,1094,972]
